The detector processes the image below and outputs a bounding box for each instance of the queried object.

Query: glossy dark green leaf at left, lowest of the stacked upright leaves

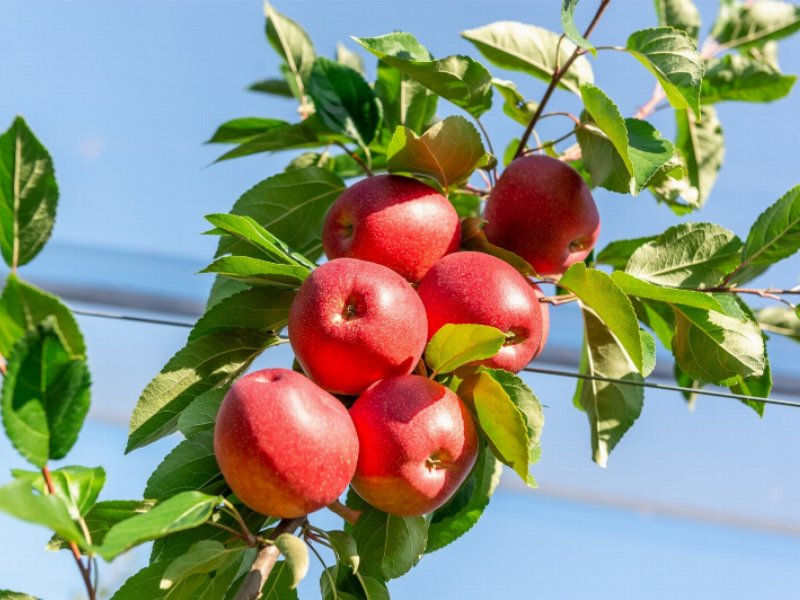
[2,317,90,468]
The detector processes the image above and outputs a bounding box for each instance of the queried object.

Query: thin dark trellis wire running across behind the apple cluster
[72,309,800,408]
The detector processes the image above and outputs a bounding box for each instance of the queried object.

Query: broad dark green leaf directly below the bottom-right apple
[353,507,428,581]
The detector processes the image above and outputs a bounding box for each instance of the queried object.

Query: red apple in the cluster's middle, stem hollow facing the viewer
[289,258,427,396]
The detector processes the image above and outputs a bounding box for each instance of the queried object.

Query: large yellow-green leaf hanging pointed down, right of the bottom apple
[458,367,544,487]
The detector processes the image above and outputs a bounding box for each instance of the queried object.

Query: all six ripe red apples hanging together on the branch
[214,156,600,518]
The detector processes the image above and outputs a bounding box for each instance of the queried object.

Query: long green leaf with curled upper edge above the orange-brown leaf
[353,32,492,117]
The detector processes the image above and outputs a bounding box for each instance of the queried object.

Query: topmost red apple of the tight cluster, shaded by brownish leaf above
[322,175,461,282]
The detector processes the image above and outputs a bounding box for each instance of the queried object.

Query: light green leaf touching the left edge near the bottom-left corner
[0,480,86,548]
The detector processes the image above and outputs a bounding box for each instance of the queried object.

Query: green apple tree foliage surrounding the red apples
[0,0,800,600]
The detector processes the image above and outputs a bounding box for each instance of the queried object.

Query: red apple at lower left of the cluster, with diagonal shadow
[214,369,358,519]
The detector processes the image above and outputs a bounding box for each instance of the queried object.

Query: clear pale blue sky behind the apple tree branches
[0,0,800,600]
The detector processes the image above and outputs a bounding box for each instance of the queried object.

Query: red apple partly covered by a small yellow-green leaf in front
[417,252,542,373]
